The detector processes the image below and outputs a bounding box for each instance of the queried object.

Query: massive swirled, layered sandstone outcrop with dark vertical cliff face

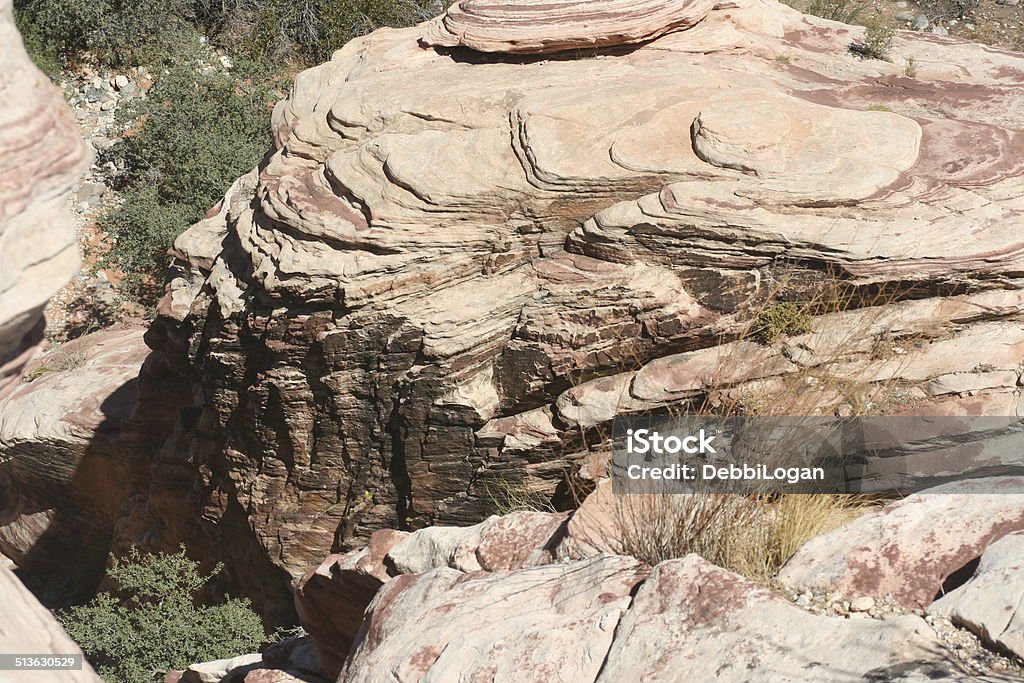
[124,0,1024,621]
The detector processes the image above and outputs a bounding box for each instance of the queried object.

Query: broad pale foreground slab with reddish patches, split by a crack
[339,555,951,683]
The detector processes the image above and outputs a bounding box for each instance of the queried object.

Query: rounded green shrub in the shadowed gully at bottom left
[58,549,265,683]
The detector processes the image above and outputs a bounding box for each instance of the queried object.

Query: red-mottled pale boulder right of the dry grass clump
[779,477,1024,609]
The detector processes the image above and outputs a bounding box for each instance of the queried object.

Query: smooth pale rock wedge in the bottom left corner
[0,567,101,683]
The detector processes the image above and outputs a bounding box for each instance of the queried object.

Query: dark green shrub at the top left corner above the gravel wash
[15,0,195,71]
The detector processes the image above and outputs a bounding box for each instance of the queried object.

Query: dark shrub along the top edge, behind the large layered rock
[199,0,449,63]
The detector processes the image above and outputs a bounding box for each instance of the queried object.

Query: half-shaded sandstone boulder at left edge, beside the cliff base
[0,330,150,597]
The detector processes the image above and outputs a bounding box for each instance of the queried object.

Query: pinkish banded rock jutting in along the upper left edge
[0,0,88,397]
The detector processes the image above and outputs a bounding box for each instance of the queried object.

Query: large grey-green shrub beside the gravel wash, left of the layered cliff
[100,61,280,302]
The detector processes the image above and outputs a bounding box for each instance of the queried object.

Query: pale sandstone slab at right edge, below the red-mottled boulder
[928,532,1024,658]
